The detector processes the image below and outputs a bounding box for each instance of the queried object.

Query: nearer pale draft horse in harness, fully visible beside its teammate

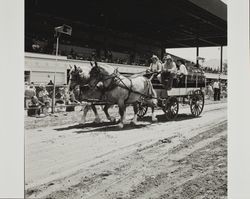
[89,62,157,128]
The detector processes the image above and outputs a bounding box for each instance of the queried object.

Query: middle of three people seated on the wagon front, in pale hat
[161,55,177,90]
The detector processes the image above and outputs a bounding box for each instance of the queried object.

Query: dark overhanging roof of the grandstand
[25,0,227,48]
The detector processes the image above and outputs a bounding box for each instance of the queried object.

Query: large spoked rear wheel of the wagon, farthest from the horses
[190,90,204,117]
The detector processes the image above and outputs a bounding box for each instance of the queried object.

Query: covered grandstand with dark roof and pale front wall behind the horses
[25,0,227,84]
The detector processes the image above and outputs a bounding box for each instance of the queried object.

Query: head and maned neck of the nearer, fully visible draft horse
[89,62,115,87]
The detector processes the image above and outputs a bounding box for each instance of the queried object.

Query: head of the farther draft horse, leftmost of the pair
[69,65,89,91]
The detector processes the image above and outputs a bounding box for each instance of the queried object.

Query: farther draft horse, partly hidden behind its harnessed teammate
[68,65,115,124]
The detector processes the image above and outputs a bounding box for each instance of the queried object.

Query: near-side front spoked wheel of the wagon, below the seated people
[162,97,179,120]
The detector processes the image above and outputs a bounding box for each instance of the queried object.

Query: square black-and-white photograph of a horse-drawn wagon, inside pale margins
[23,0,230,199]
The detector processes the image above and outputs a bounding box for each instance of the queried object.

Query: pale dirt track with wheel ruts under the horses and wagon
[25,103,227,199]
